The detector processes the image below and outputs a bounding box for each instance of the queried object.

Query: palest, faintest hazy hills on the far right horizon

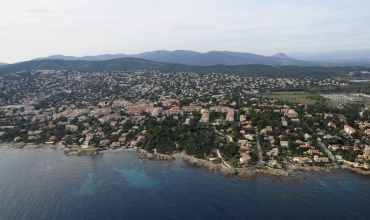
[288,49,370,61]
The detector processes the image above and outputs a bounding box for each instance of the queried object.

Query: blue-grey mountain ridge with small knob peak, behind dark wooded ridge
[35,50,307,66]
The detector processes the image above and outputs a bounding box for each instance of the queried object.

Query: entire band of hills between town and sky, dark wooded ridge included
[0,50,370,76]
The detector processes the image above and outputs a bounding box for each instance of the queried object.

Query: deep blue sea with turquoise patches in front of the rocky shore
[0,147,370,219]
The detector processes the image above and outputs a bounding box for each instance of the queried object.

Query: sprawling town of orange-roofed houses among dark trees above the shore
[0,70,370,173]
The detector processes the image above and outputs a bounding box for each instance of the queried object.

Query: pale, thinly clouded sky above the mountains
[0,0,370,63]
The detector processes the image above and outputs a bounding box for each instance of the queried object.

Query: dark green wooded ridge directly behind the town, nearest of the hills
[0,57,364,77]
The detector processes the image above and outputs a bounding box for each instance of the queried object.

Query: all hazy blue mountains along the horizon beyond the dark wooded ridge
[0,49,370,66]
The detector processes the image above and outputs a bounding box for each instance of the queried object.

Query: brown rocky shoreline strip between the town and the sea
[0,142,370,181]
